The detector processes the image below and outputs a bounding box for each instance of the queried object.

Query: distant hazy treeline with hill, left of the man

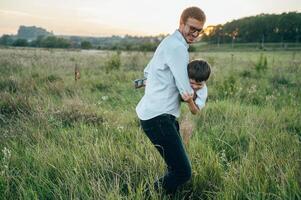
[0,26,165,51]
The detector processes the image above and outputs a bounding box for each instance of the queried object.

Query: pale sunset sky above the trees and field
[0,0,301,36]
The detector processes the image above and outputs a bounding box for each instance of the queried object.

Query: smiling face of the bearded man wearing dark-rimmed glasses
[179,18,204,44]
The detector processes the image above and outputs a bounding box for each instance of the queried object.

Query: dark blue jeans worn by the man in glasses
[140,114,191,193]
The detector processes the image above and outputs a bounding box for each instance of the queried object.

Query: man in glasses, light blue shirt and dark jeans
[136,7,206,194]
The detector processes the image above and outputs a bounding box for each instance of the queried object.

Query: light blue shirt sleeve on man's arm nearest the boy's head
[167,46,193,95]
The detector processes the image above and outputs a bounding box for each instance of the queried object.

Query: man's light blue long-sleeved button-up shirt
[136,30,193,120]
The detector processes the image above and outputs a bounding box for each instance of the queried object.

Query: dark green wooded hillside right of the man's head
[203,12,301,43]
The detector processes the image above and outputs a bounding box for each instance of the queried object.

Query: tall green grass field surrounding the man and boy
[0,49,301,200]
